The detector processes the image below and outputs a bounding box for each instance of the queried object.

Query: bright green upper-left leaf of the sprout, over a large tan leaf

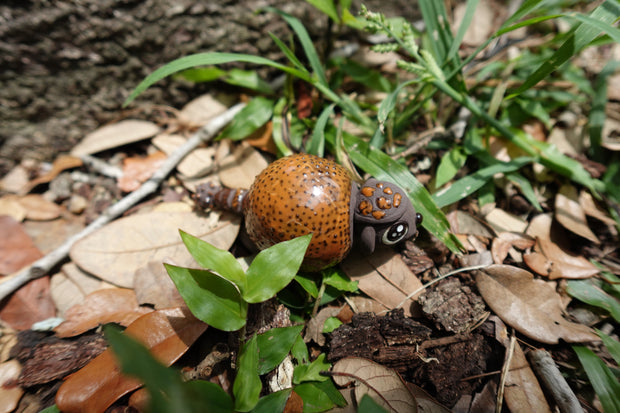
[179,230,246,291]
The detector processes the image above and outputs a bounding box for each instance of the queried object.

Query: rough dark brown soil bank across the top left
[0,0,418,176]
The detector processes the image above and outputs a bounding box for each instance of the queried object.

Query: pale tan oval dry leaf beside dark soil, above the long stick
[71,119,159,156]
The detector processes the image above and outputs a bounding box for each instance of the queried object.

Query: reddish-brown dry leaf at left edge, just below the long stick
[0,276,56,330]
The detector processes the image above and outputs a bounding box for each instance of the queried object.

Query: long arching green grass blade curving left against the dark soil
[123,52,310,106]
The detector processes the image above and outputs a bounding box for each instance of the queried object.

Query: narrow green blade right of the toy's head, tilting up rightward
[433,157,532,208]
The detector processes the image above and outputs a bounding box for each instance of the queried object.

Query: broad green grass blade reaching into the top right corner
[507,0,620,99]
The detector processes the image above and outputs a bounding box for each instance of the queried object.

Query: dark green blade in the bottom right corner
[573,346,620,412]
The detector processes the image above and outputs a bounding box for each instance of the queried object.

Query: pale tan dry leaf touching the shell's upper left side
[218,143,268,189]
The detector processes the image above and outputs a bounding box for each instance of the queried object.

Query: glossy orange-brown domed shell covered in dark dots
[243,154,353,271]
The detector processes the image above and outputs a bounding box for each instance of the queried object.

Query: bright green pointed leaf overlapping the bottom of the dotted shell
[243,234,312,303]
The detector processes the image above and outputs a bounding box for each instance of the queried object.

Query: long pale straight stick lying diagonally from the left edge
[0,103,245,300]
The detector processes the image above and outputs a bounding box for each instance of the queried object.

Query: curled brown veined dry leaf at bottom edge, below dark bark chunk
[331,357,418,413]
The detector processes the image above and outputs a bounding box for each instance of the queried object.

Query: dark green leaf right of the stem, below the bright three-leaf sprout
[257,325,304,374]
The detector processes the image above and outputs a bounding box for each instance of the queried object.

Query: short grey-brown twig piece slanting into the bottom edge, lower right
[528,350,583,413]
